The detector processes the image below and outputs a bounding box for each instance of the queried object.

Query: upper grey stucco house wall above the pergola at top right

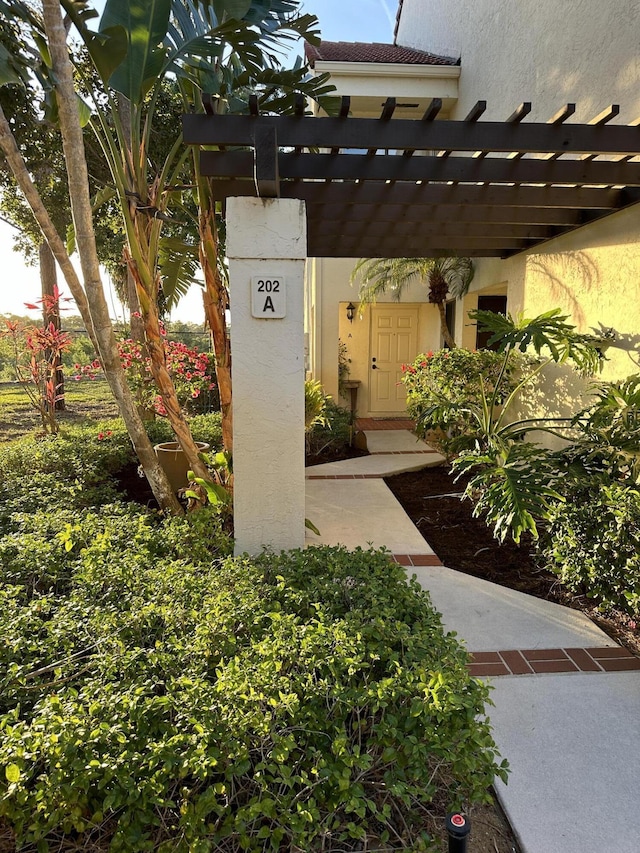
[397,0,640,122]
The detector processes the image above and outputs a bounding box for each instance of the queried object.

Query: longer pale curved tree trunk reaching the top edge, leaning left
[43,0,182,514]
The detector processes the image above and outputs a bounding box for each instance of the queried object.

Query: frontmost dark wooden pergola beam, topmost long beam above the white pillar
[183,114,639,155]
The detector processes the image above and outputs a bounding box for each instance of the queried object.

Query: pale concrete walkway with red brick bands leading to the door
[306,424,640,853]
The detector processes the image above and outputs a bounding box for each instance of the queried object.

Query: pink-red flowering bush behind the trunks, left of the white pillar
[75,326,216,417]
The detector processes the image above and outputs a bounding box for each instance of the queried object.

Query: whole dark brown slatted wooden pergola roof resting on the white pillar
[183,98,640,258]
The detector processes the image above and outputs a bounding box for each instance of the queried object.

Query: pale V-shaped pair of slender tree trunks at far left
[0,0,182,513]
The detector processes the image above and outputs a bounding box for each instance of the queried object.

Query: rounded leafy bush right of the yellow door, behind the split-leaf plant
[402,349,522,456]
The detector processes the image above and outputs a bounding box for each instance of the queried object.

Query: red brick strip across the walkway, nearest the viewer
[468,646,640,677]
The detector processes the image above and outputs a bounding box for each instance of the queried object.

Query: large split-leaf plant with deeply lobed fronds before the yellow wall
[440,309,603,542]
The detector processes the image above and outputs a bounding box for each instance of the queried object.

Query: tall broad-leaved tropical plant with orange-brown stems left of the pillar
[63,0,338,462]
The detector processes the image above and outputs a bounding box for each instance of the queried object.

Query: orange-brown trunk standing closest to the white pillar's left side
[199,210,233,453]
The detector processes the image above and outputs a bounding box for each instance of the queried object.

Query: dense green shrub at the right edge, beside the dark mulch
[540,483,640,618]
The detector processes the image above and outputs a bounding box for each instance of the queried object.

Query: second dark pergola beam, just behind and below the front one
[200,151,640,186]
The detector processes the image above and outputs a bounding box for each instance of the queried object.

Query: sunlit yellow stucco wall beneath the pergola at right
[457,209,640,443]
